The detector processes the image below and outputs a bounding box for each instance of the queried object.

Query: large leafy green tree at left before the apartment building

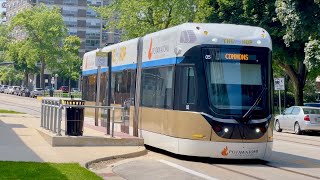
[10,5,67,88]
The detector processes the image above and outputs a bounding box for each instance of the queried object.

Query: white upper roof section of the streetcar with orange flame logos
[83,23,272,74]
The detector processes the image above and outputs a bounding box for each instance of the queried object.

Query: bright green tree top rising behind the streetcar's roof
[94,0,212,40]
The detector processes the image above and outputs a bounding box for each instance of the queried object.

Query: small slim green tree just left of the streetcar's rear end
[58,36,82,92]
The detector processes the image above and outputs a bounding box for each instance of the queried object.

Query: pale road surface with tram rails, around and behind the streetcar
[0,94,320,180]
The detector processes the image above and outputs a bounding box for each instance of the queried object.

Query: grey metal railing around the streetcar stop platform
[40,98,125,137]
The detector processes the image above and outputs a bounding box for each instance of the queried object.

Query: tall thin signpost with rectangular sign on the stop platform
[94,51,108,126]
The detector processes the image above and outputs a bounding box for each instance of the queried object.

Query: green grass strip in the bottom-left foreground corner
[0,161,102,180]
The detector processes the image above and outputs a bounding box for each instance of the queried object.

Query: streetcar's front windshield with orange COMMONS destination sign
[203,48,268,116]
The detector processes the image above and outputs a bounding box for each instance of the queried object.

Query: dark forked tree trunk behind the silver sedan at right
[279,61,307,106]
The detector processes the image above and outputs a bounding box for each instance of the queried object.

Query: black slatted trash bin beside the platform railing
[65,100,85,136]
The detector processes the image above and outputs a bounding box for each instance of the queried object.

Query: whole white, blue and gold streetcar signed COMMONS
[82,23,274,159]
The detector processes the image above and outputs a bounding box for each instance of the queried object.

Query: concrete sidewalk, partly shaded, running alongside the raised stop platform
[0,114,146,166]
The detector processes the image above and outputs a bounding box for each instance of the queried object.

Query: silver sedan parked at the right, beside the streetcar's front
[275,106,320,134]
